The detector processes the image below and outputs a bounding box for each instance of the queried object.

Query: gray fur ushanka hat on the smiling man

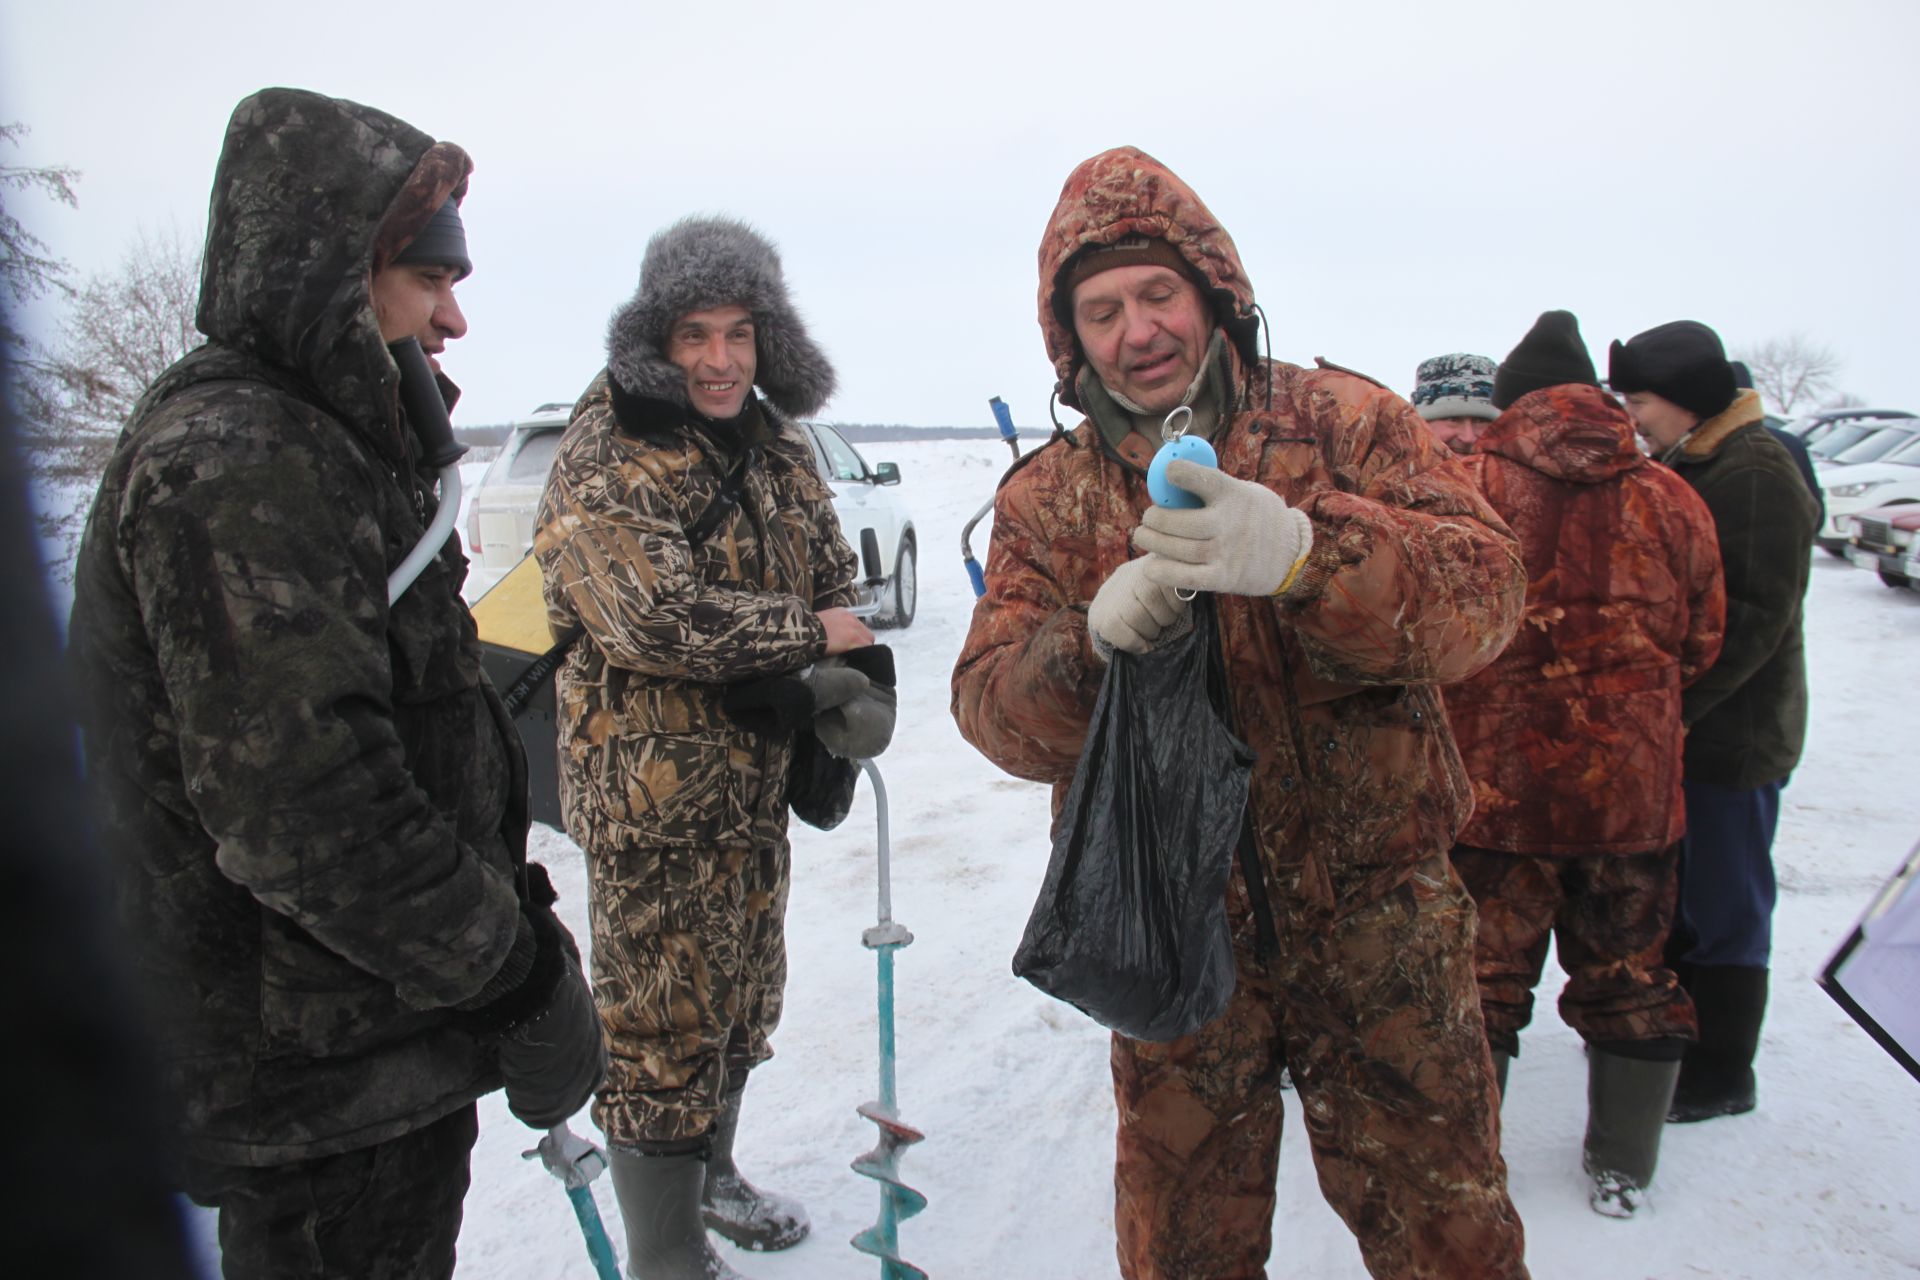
[607,215,833,418]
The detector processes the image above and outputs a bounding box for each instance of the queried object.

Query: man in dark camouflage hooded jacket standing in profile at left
[71,88,603,1280]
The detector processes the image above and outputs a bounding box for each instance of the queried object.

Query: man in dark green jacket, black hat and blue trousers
[1607,320,1818,1123]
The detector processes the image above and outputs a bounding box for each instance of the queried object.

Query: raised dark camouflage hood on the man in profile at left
[187,88,472,466]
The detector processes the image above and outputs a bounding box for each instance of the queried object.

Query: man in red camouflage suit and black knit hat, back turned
[1446,311,1726,1217]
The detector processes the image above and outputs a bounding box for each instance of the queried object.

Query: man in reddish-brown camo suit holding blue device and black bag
[952,148,1526,1280]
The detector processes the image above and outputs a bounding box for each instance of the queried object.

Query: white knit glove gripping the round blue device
[1128,462,1313,595]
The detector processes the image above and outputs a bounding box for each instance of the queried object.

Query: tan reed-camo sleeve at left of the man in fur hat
[534,413,851,683]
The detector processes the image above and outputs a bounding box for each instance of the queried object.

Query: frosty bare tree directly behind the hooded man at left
[17,228,202,578]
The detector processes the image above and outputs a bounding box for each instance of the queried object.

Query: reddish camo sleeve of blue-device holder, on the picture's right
[1281,372,1526,685]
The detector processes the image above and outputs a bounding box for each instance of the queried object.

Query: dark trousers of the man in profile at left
[186,1103,480,1280]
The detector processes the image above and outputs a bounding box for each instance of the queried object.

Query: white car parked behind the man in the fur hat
[467,403,920,628]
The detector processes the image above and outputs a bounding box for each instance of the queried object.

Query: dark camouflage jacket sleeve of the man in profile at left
[117,395,518,1007]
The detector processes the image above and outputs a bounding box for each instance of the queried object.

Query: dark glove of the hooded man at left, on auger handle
[455,865,607,1128]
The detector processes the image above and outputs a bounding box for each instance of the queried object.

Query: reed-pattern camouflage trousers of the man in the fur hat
[588,837,789,1150]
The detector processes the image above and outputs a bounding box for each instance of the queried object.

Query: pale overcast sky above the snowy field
[0,0,1920,428]
